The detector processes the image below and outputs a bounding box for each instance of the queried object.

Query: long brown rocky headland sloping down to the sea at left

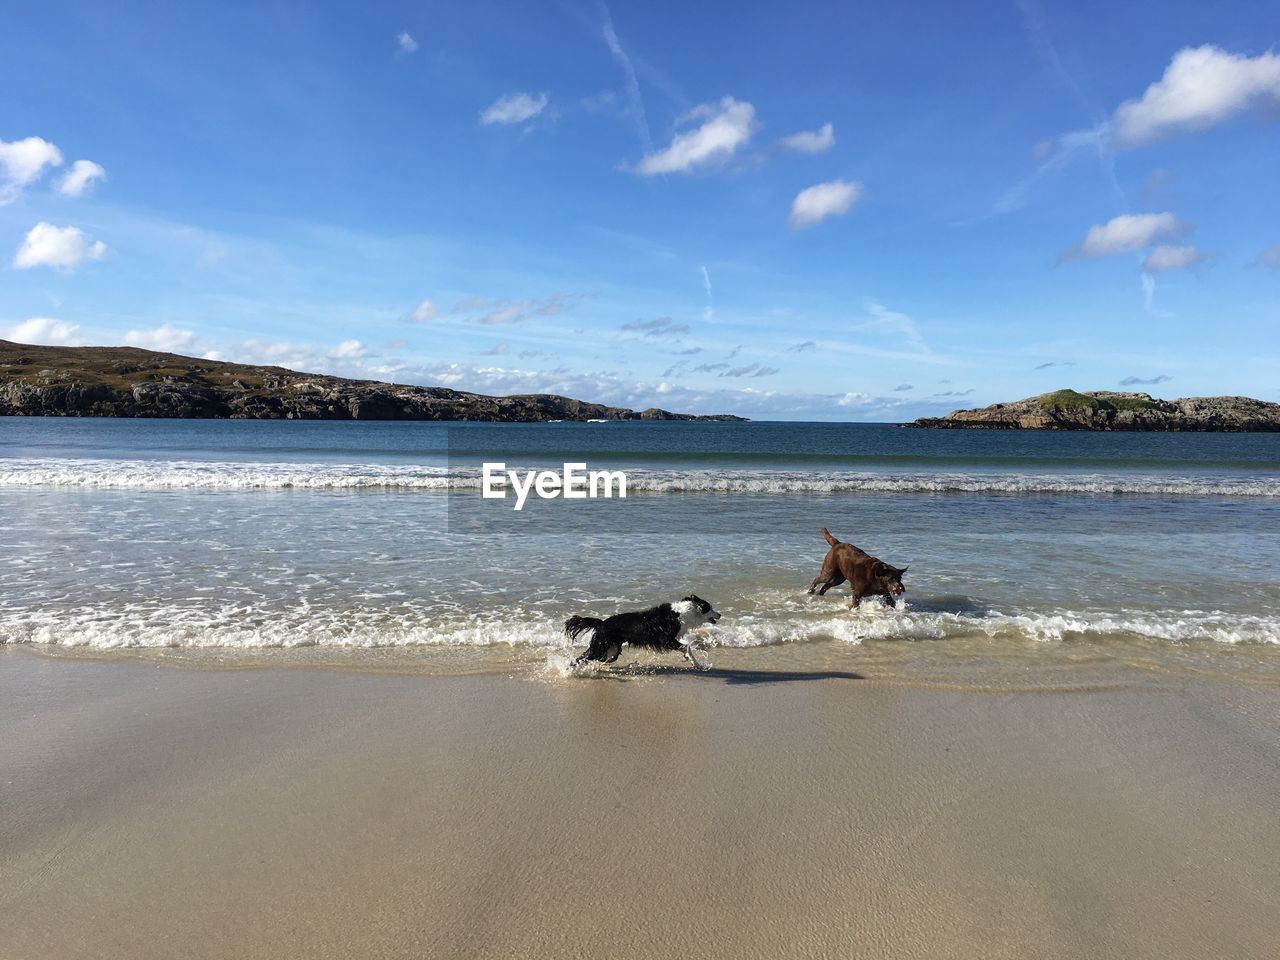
[0,340,744,422]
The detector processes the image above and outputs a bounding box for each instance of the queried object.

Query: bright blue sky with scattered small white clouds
[0,0,1280,421]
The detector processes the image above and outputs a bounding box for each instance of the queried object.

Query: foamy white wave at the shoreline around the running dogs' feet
[0,600,1280,650]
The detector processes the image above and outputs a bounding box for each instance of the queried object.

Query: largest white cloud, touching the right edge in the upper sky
[1111,45,1280,147]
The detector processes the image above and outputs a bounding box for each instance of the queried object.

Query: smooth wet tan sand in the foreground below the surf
[0,648,1280,960]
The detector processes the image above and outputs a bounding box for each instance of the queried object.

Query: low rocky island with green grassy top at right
[906,390,1280,433]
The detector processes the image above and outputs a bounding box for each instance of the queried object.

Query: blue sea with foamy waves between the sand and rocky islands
[0,417,1280,689]
